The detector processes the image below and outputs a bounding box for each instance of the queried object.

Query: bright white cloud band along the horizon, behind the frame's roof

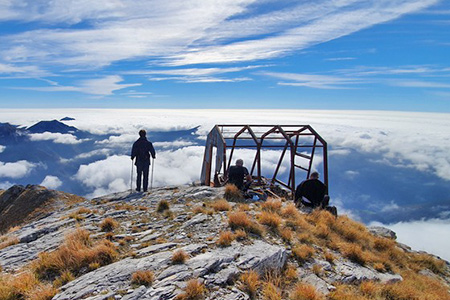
[1,109,450,180]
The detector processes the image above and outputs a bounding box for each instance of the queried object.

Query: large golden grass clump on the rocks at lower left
[31,229,118,280]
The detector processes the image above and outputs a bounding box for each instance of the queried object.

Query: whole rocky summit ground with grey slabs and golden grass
[0,186,450,300]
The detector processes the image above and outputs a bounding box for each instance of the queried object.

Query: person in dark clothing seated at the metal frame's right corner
[294,172,330,208]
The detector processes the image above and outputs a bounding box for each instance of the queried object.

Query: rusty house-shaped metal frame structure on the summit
[201,125,328,195]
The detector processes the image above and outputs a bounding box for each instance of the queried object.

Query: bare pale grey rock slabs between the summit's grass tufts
[0,186,450,300]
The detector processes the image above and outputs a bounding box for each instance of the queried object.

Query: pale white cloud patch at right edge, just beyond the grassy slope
[371,219,450,261]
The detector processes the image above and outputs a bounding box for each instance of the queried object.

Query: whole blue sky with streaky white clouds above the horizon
[0,0,450,112]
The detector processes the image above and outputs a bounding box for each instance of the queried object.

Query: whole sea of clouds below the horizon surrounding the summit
[0,109,450,260]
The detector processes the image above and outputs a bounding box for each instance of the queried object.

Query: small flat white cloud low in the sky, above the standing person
[20,75,142,96]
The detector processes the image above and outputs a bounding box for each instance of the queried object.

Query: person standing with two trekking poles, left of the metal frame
[131,129,156,192]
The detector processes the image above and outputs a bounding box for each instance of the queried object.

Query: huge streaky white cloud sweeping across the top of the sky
[0,0,438,67]
